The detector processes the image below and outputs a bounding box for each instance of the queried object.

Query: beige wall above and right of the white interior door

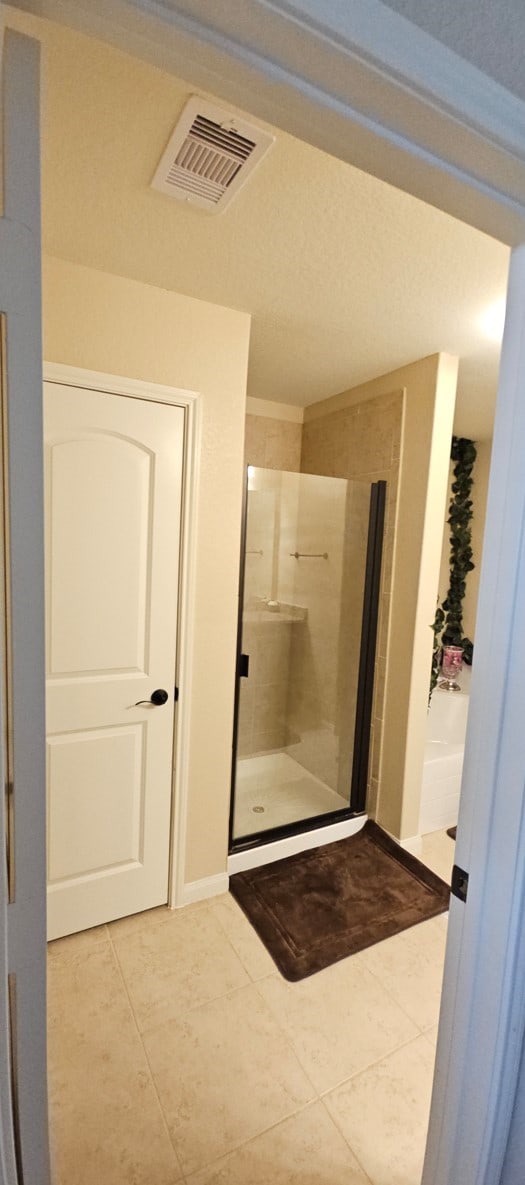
[44,257,250,882]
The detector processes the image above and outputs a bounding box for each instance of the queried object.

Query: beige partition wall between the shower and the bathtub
[305,354,457,839]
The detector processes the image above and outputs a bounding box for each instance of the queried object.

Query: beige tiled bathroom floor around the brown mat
[49,833,454,1185]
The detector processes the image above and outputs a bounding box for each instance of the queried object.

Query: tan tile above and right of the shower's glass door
[301,391,403,814]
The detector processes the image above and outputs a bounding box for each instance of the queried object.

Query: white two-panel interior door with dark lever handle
[44,383,184,937]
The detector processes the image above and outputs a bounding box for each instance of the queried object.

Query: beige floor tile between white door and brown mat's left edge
[114,909,249,1032]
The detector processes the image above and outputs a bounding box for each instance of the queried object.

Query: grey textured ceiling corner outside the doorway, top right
[383,0,525,100]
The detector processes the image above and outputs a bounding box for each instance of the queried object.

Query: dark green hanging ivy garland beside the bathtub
[429,436,476,702]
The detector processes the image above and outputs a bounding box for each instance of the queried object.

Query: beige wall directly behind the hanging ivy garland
[440,441,492,641]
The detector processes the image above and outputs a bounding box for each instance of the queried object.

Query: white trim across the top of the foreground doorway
[9,0,525,243]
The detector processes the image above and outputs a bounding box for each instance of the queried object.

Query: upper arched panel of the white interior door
[47,434,154,678]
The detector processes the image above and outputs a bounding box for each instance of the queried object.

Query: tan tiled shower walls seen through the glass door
[238,467,370,798]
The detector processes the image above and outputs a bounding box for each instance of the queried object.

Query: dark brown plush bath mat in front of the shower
[230,822,449,980]
